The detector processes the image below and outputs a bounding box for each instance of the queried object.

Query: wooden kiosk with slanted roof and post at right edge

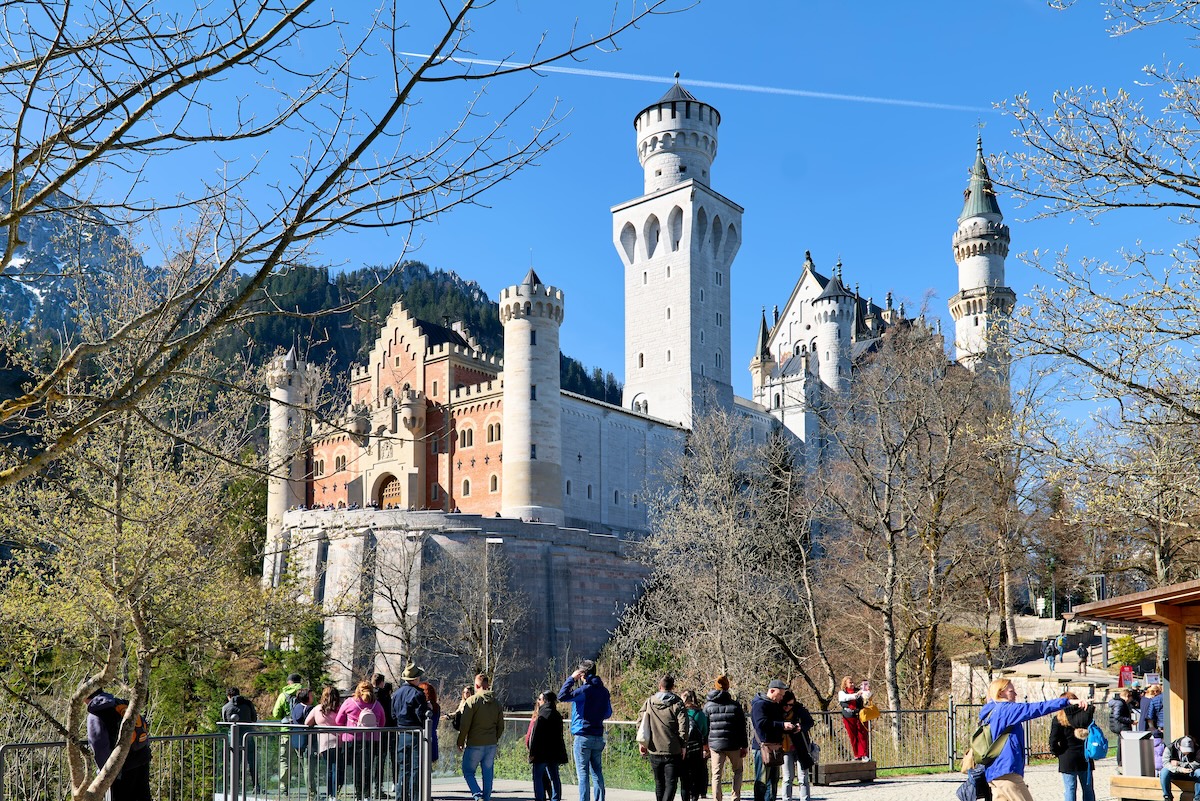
[1063,579,1200,801]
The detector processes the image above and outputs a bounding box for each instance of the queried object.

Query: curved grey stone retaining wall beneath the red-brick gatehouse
[286,510,648,703]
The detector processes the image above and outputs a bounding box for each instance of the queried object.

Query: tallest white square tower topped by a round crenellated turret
[612,83,742,427]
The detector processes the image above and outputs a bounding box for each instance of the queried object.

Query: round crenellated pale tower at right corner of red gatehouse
[500,270,564,525]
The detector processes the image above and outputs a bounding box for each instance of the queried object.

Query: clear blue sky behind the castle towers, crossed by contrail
[140,0,1186,395]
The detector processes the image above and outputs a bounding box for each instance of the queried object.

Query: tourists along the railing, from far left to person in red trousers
[89,660,870,801]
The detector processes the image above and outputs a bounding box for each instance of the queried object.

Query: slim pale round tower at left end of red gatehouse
[263,348,318,586]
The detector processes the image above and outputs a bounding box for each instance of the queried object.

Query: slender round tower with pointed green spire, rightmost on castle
[950,137,1016,379]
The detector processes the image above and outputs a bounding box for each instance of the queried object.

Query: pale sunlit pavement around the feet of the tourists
[433,759,1116,801]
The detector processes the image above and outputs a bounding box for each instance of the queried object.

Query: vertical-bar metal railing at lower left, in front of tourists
[0,722,432,801]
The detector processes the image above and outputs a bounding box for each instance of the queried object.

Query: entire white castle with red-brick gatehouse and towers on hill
[264,83,1015,679]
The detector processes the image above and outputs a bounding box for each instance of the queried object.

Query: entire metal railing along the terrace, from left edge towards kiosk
[0,699,1080,801]
